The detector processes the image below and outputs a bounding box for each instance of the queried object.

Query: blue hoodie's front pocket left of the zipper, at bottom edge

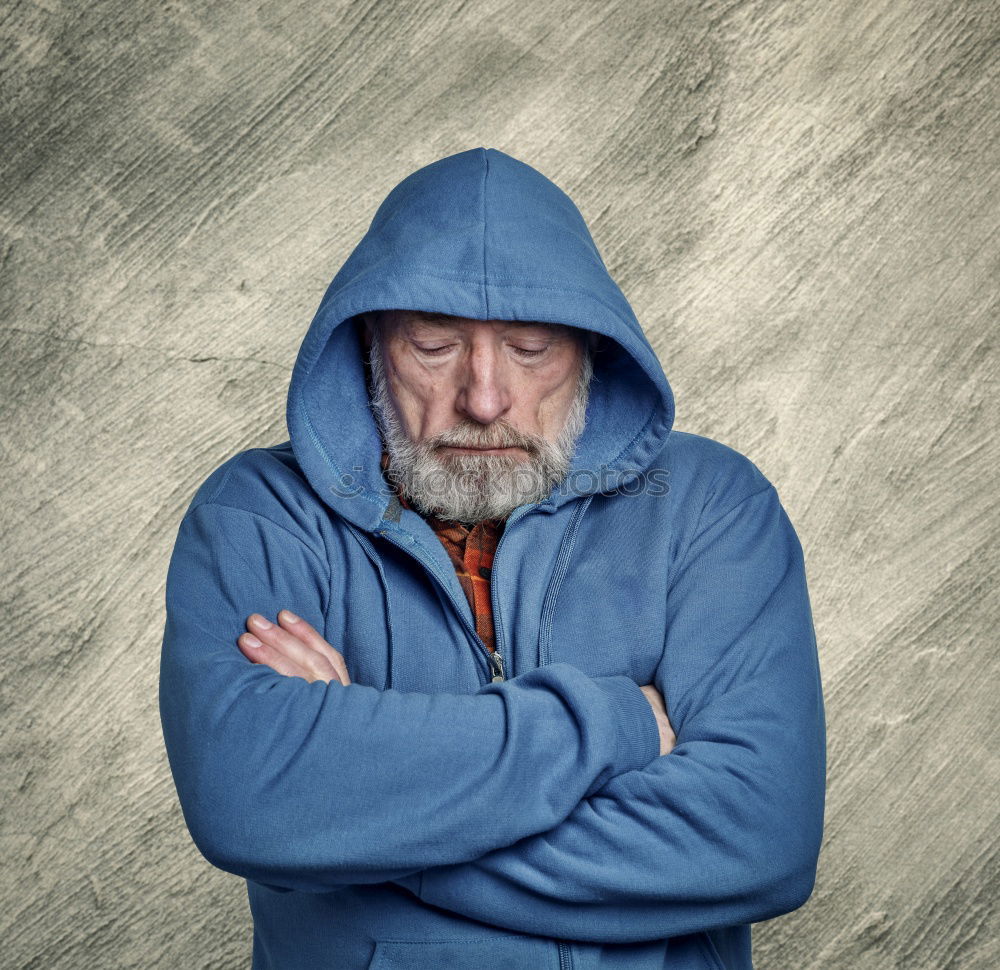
[368,936,559,970]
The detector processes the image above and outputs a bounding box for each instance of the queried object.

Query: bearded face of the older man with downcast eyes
[364,310,591,523]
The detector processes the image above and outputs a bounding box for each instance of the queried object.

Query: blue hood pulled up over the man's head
[287,148,674,529]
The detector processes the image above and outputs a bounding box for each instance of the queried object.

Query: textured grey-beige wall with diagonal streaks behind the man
[0,0,1000,970]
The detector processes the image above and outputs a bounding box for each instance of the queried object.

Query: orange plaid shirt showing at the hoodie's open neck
[382,449,506,653]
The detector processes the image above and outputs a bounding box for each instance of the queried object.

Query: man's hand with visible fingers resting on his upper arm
[236,610,351,684]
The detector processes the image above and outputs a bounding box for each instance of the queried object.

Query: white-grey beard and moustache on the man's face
[370,327,593,525]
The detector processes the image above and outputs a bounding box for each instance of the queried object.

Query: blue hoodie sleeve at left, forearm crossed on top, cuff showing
[159,502,659,892]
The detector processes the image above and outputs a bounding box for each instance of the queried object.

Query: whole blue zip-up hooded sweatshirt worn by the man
[159,148,826,970]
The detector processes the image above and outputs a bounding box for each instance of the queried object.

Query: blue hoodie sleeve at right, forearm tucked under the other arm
[403,476,826,943]
